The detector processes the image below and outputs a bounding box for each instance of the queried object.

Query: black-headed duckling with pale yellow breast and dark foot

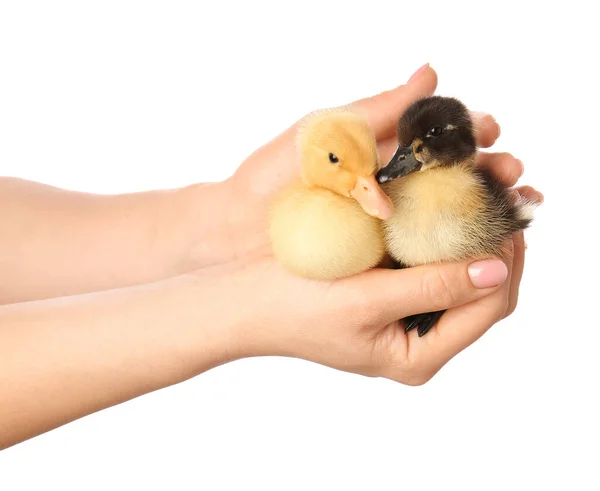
[377,96,536,336]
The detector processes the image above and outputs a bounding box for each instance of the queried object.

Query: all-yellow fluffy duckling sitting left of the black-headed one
[269,108,392,280]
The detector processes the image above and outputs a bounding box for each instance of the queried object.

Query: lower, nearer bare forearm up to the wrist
[0,274,237,449]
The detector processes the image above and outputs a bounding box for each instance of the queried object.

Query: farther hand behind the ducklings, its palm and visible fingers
[221,66,536,261]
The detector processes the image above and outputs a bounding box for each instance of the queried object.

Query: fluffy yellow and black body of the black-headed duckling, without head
[383,164,532,266]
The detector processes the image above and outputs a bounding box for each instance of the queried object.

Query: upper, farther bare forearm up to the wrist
[0,178,233,304]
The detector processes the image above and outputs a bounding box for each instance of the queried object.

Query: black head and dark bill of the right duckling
[377,96,477,183]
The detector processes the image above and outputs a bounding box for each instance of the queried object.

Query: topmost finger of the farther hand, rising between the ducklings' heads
[349,64,437,140]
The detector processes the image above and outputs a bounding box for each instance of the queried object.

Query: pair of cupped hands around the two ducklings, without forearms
[216,66,542,385]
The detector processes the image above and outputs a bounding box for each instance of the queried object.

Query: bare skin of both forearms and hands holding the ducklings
[0,67,542,448]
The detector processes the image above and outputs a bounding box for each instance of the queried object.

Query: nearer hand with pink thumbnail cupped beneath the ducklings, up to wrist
[220,202,538,385]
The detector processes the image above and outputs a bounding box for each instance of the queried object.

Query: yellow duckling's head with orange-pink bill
[297,109,393,220]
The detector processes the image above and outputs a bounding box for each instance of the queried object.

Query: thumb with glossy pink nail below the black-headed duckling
[345,259,508,324]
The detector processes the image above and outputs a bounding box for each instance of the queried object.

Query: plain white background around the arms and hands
[0,0,600,491]
